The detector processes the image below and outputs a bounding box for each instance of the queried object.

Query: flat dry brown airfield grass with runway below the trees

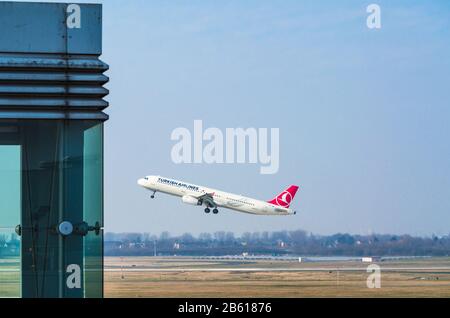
[105,257,450,297]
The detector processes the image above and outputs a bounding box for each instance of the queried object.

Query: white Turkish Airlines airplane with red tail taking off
[137,176,299,215]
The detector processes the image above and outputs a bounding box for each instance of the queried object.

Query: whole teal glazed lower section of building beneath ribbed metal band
[0,120,103,297]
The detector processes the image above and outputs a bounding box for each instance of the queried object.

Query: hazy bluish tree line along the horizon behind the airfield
[105,230,450,256]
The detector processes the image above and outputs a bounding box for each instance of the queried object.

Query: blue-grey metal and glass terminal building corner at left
[0,2,108,298]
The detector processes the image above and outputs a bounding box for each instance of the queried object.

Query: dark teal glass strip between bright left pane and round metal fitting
[18,120,63,298]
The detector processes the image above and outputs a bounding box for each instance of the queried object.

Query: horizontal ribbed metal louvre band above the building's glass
[0,53,109,117]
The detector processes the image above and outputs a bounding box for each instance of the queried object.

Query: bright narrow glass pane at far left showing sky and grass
[0,145,21,297]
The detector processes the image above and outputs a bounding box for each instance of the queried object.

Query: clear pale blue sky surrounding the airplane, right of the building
[19,0,450,235]
